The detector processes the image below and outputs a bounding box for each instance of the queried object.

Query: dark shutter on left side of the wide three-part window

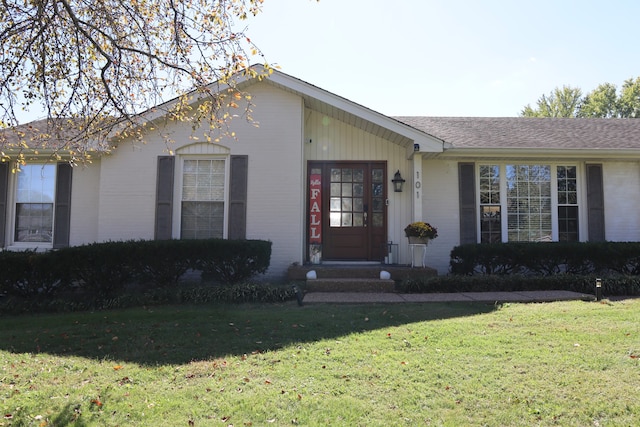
[458,163,478,245]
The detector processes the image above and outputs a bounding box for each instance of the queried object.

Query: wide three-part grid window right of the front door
[478,164,579,243]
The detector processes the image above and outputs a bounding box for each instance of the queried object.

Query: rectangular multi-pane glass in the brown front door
[329,168,365,227]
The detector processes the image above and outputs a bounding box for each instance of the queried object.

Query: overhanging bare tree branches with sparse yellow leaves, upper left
[0,0,268,162]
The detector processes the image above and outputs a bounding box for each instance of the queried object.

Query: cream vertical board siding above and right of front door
[304,109,414,262]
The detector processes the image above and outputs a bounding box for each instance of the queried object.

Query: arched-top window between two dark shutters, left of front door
[180,159,225,239]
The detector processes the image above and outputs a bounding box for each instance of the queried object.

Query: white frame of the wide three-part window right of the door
[475,163,588,243]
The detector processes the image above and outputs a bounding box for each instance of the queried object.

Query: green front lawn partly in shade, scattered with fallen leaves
[0,300,640,427]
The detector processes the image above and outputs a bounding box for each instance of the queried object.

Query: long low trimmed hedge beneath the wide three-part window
[449,242,640,276]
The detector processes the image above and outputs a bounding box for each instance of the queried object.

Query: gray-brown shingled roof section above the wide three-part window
[394,117,640,150]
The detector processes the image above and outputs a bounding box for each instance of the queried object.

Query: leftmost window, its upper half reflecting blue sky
[14,164,56,243]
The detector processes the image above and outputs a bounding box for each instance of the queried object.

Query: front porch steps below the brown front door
[288,263,437,293]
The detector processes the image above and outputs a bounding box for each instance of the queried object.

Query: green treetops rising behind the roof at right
[520,77,640,118]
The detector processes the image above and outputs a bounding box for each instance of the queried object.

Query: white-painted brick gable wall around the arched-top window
[97,83,304,275]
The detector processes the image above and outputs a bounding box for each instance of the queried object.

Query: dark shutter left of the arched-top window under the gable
[155,156,175,240]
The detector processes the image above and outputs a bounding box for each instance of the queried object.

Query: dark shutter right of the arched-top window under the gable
[228,156,249,239]
